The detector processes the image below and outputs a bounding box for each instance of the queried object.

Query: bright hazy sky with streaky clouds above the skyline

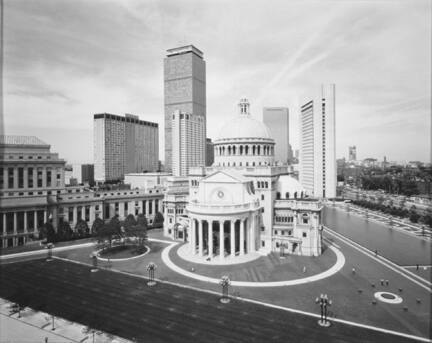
[0,0,432,163]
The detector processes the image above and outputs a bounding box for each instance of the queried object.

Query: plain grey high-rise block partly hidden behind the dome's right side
[263,107,290,164]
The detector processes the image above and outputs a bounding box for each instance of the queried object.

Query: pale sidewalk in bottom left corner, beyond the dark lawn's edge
[0,298,129,343]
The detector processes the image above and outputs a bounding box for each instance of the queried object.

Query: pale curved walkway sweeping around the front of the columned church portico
[161,243,345,287]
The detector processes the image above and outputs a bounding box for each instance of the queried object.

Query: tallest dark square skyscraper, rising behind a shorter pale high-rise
[164,45,206,171]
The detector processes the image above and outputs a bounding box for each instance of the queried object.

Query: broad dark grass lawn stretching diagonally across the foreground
[0,260,418,342]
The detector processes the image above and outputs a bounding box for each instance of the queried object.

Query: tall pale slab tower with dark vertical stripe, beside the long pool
[300,84,336,198]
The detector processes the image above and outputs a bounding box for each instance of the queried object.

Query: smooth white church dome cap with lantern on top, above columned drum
[217,99,272,140]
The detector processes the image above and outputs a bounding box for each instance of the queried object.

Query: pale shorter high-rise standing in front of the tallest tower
[171,110,206,176]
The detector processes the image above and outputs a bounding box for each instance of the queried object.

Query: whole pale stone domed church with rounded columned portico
[164,99,322,263]
